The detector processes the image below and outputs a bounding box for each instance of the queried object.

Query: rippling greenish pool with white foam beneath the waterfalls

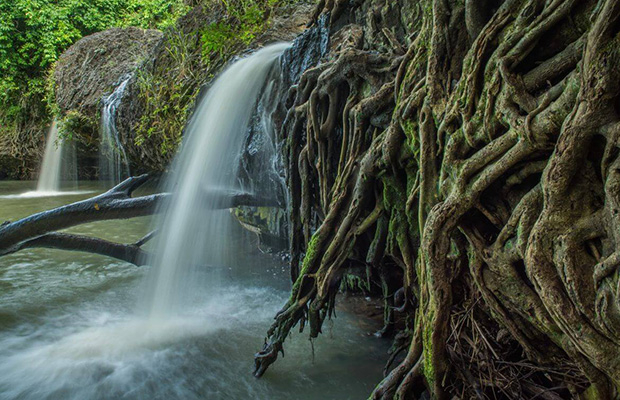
[0,181,388,400]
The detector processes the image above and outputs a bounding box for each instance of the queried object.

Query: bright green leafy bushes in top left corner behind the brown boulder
[0,0,186,138]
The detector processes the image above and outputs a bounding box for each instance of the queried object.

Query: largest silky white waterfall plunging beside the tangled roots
[146,44,289,320]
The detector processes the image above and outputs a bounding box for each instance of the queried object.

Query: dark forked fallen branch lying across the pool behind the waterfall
[0,175,280,265]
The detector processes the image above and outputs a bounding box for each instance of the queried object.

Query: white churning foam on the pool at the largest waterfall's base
[0,287,282,399]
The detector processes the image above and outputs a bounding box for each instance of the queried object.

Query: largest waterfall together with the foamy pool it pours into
[0,30,387,400]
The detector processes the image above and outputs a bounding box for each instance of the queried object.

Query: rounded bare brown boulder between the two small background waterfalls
[53,27,163,179]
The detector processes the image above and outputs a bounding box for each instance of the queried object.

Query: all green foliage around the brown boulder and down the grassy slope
[0,0,296,166]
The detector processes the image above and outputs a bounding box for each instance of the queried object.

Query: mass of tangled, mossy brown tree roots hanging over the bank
[256,0,620,399]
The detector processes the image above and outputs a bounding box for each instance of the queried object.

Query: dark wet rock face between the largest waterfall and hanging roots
[235,18,329,249]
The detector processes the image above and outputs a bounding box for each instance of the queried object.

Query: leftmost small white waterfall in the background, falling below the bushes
[37,120,63,193]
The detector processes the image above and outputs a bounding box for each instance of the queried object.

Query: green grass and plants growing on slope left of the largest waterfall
[134,0,294,163]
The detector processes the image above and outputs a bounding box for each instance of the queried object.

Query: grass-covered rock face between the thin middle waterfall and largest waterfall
[116,5,224,173]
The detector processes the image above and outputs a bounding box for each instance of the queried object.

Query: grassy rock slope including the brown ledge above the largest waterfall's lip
[117,1,313,173]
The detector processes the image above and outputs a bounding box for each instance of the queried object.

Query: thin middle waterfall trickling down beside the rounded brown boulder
[99,76,131,184]
